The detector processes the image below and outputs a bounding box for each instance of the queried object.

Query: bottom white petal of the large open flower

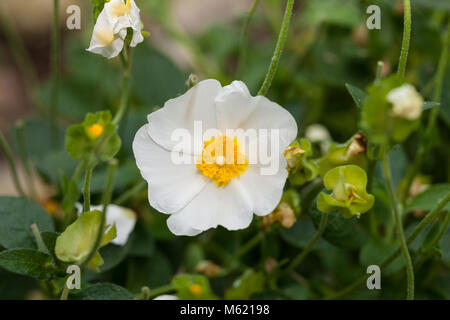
[167,179,253,235]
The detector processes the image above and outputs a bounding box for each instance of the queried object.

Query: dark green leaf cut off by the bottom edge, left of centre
[70,283,136,300]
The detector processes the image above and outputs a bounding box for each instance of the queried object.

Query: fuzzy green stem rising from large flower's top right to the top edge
[258,0,295,96]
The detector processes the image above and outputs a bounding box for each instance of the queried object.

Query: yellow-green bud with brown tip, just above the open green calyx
[318,131,368,177]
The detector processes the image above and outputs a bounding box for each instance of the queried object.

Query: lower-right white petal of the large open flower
[239,162,288,216]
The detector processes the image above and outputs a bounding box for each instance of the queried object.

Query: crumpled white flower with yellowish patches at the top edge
[87,0,144,59]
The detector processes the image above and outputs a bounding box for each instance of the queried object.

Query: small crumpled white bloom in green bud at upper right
[387,84,423,120]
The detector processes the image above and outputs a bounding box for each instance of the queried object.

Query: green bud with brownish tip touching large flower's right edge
[284,139,318,186]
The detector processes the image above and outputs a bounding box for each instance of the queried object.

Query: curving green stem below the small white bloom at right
[383,151,414,300]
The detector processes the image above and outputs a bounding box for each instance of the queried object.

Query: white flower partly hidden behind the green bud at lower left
[75,203,136,246]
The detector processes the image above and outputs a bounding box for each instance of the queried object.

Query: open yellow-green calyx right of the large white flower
[317,165,375,218]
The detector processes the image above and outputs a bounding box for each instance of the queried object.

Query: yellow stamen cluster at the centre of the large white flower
[197,136,248,186]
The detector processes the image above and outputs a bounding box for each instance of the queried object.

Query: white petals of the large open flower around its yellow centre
[133,80,297,236]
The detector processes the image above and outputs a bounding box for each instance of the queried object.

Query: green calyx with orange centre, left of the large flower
[66,111,121,161]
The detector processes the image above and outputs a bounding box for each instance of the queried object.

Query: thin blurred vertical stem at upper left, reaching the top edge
[50,0,60,149]
